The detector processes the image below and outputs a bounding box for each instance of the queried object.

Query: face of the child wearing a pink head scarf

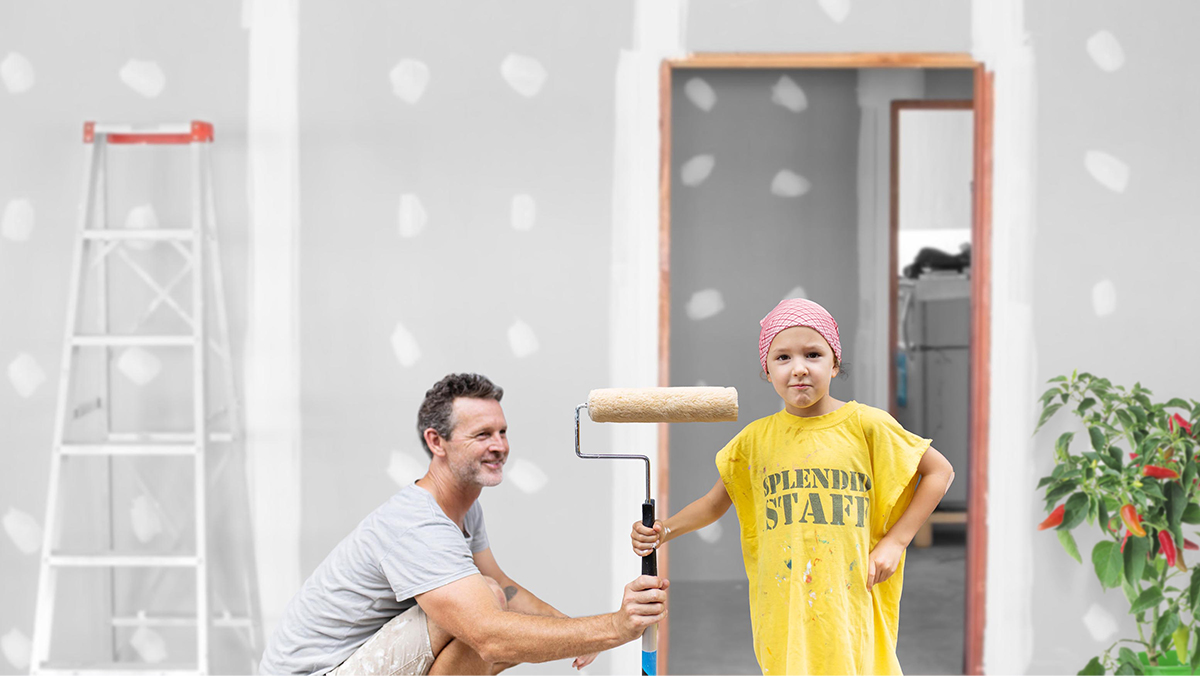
[767,327,840,418]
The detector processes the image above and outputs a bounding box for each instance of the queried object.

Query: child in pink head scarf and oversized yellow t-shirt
[631,299,954,675]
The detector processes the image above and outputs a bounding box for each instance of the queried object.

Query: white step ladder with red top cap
[31,121,260,675]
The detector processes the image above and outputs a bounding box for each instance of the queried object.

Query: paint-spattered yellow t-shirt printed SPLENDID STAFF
[716,401,930,675]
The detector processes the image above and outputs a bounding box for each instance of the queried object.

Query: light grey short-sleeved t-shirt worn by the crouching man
[258,484,487,675]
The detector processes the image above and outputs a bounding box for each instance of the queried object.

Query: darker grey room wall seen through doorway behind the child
[664,67,973,674]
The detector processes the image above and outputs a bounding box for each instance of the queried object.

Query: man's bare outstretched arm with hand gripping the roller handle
[416,575,668,664]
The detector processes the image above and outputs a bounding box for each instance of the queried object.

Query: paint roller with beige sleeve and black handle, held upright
[575,388,738,676]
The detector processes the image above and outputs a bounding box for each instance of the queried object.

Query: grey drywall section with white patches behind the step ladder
[0,1,248,674]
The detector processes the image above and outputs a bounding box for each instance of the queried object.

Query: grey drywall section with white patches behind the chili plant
[1022,1,1200,674]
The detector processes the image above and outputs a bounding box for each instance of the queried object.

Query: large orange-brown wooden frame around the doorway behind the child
[656,53,994,674]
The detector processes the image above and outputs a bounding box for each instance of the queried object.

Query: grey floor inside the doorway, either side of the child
[670,526,966,675]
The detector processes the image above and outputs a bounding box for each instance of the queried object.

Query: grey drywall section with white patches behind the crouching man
[292,1,640,674]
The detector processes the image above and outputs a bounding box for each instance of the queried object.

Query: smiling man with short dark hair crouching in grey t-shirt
[259,373,668,676]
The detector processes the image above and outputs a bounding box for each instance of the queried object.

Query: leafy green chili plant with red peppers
[1038,372,1200,674]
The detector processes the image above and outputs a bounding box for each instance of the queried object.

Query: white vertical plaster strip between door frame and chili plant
[972,0,1038,674]
